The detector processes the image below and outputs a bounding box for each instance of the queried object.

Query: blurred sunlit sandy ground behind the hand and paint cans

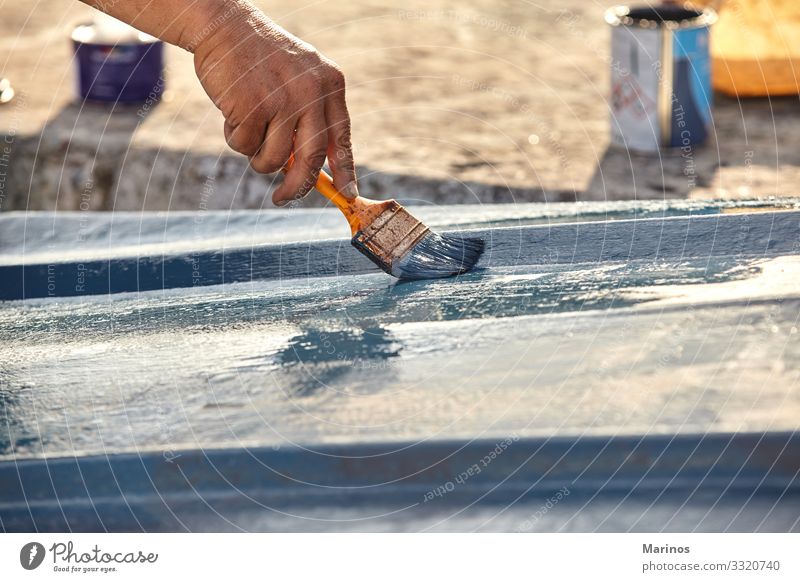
[0,0,800,209]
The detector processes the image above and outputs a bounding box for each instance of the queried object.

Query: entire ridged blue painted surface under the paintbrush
[0,203,800,531]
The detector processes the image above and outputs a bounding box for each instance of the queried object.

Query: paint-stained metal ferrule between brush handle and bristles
[351,200,430,276]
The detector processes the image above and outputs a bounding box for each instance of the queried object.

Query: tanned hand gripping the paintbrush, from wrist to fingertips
[191,2,358,206]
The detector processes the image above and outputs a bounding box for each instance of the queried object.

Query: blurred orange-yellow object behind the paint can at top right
[689,0,800,97]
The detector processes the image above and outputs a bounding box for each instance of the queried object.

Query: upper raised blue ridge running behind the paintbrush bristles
[0,212,800,300]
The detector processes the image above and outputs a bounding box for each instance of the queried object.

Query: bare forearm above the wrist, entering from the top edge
[81,0,256,52]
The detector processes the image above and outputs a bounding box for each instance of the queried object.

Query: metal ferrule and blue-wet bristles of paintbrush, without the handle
[352,200,483,279]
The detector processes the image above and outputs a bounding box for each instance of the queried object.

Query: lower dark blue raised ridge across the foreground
[0,433,800,529]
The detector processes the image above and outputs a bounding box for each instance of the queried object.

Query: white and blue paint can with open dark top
[606,5,717,152]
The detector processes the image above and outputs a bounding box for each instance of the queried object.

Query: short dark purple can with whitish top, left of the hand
[72,15,164,104]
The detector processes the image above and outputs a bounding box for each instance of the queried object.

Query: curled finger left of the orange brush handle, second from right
[272,104,328,206]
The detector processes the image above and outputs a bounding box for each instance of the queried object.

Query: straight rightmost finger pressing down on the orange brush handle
[325,70,358,198]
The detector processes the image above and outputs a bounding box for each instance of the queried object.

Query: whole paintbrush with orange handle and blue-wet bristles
[284,170,484,279]
